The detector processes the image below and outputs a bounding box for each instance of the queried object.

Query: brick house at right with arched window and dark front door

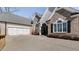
[39,7,79,35]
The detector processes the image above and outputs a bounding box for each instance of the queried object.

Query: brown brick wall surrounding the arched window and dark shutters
[48,10,79,35]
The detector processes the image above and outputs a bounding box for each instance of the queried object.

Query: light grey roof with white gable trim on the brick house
[40,7,79,22]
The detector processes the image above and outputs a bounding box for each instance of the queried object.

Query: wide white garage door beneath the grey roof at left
[8,27,30,35]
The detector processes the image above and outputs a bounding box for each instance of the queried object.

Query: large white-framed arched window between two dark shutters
[53,20,68,32]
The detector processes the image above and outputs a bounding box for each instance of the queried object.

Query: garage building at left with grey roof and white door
[0,13,31,35]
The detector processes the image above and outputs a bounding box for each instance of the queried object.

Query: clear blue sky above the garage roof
[13,7,46,19]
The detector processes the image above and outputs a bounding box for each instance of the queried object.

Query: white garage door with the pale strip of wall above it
[7,26,30,35]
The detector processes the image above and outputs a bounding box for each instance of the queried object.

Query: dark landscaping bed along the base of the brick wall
[47,33,79,41]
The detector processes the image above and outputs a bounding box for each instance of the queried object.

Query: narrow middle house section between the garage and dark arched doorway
[32,13,42,34]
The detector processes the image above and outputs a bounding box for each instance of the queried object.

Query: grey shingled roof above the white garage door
[0,13,31,25]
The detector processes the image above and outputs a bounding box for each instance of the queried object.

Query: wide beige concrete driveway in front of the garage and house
[3,35,79,51]
